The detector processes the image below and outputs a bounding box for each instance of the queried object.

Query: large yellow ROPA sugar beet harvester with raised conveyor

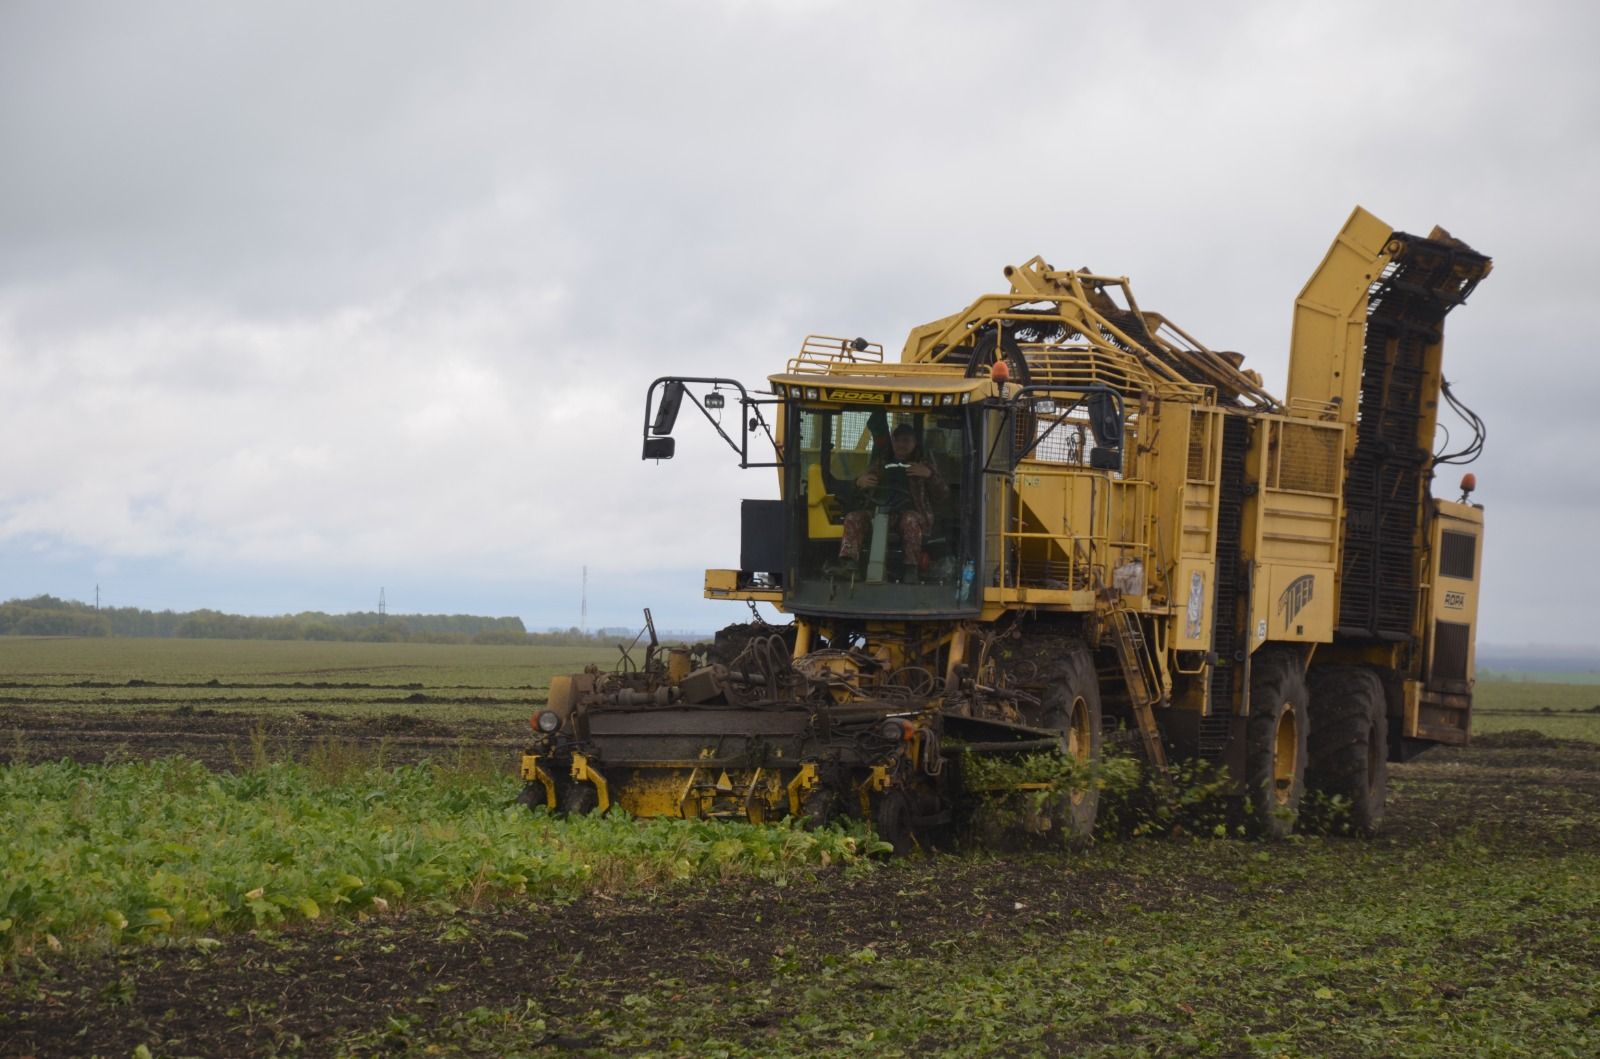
[522,208,1490,849]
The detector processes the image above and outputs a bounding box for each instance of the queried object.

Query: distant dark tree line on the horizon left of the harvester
[0,595,614,645]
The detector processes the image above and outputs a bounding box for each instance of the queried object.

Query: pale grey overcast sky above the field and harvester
[0,0,1600,646]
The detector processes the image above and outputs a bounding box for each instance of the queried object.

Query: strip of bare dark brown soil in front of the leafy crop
[0,857,1229,1056]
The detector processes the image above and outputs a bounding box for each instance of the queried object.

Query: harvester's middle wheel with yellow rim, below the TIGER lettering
[1245,648,1310,838]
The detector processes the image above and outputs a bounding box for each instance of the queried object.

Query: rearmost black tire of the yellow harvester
[1306,665,1389,835]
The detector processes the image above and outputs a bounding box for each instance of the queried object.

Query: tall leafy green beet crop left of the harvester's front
[0,758,862,953]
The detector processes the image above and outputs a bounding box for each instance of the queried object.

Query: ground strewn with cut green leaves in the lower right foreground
[492,841,1600,1056]
